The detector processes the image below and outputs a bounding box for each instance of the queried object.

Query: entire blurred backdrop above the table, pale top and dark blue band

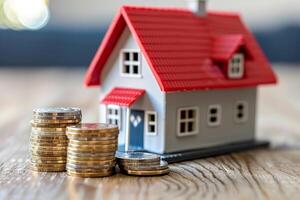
[0,0,300,67]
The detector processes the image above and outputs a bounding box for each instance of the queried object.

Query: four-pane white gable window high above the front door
[121,50,141,77]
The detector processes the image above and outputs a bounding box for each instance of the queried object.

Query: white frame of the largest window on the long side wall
[177,107,199,137]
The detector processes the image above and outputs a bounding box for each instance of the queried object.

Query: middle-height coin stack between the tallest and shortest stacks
[67,123,119,178]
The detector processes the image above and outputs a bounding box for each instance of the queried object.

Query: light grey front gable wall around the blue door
[100,27,165,152]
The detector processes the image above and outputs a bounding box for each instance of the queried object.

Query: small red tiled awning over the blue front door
[101,88,145,107]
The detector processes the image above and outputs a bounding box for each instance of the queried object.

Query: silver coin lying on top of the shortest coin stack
[116,151,160,161]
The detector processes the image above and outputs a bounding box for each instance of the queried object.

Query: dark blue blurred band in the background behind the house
[0,26,300,66]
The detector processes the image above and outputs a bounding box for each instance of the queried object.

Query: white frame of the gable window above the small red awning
[120,49,142,78]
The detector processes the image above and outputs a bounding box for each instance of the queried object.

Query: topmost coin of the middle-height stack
[67,123,119,133]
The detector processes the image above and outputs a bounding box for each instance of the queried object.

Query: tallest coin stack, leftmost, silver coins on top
[30,108,81,172]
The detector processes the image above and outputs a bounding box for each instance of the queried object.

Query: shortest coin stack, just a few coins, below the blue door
[116,152,169,176]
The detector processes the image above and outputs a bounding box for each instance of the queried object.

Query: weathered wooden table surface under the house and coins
[0,66,300,200]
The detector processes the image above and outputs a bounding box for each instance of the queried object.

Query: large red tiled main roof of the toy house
[85,6,276,92]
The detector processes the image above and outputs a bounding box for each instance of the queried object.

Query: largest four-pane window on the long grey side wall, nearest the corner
[177,107,199,136]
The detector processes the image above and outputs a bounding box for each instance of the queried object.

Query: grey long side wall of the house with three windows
[165,88,256,153]
